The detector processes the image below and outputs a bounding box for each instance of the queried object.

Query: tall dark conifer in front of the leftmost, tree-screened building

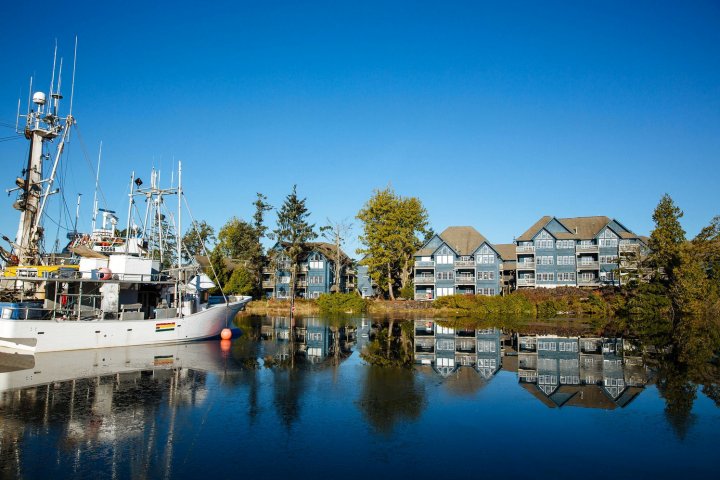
[273,185,317,301]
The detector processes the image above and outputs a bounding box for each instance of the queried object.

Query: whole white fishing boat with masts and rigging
[0,47,251,353]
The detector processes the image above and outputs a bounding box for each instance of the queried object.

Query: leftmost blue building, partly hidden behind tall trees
[262,242,356,299]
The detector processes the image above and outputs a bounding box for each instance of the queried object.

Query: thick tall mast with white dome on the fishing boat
[10,53,75,265]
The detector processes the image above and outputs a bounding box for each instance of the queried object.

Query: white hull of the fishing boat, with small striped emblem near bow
[0,297,250,353]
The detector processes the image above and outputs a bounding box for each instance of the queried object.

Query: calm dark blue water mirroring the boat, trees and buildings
[0,318,720,478]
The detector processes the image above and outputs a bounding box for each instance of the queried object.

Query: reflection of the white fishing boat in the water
[0,342,226,478]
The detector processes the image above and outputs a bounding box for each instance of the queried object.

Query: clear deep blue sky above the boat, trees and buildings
[0,0,720,253]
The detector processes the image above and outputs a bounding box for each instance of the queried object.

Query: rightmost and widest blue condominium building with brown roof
[515,216,647,288]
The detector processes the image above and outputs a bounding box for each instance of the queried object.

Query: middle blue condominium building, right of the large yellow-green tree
[414,227,510,300]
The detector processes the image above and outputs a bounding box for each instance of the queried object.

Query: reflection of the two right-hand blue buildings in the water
[414,320,648,409]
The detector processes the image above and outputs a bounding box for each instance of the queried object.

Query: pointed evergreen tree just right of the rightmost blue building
[648,193,685,283]
